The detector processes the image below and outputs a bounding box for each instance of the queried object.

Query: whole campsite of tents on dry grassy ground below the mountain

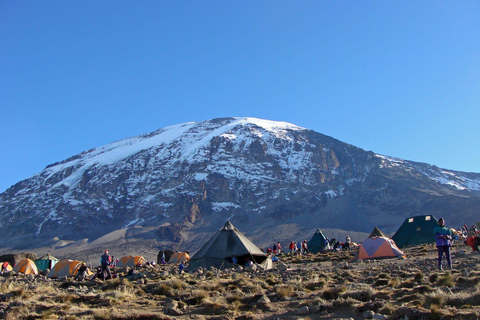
[0,216,480,320]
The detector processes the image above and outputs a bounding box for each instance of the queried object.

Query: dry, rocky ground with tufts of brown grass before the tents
[0,245,480,320]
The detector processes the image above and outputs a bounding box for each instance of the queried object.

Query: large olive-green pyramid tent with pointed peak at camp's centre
[188,221,272,269]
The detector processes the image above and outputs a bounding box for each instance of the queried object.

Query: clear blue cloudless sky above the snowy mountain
[0,0,480,192]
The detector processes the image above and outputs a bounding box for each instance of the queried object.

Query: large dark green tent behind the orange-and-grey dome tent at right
[392,215,438,248]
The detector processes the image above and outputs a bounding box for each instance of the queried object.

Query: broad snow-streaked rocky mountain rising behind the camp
[0,118,480,250]
